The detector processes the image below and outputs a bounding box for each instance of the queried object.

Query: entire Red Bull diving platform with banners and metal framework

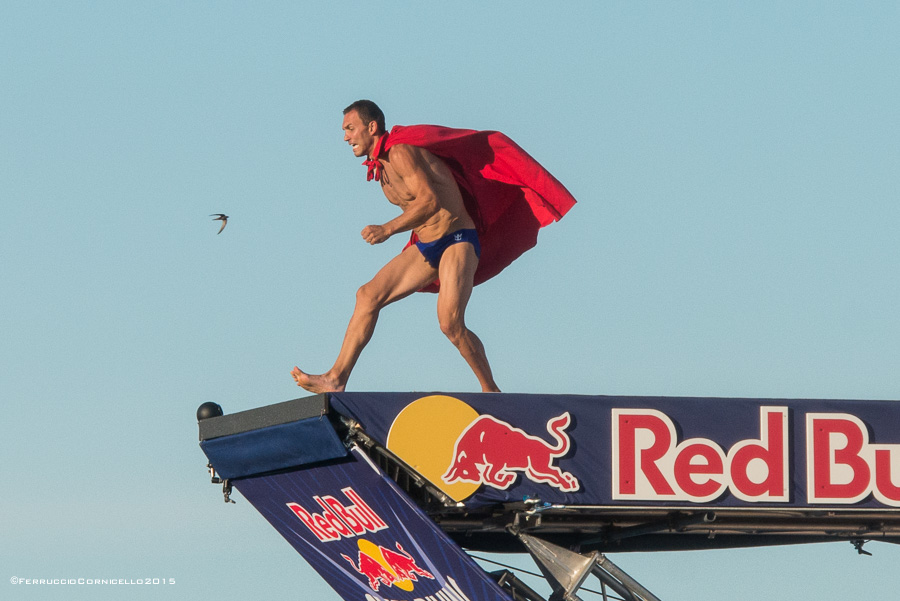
[198,392,900,601]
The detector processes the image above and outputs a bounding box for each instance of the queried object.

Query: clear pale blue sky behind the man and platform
[0,0,900,601]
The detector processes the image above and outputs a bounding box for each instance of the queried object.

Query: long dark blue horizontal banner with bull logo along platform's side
[330,393,900,509]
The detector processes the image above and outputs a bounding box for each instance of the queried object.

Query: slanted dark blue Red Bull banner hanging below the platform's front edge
[234,448,510,601]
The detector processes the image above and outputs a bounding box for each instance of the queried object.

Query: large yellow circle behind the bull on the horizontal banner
[387,395,479,501]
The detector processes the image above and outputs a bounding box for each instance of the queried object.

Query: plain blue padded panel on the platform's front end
[200,416,347,479]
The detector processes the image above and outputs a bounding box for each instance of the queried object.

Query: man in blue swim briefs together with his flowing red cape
[291,100,575,393]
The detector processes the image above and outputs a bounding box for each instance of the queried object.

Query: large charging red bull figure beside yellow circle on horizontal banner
[441,412,581,492]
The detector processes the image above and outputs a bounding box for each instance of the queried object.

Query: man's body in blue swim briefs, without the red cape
[291,100,500,393]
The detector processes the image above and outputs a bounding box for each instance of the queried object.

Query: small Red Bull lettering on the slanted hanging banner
[287,487,388,543]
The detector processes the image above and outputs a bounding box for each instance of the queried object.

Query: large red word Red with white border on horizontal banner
[612,407,789,503]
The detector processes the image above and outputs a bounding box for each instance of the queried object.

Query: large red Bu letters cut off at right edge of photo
[806,413,900,507]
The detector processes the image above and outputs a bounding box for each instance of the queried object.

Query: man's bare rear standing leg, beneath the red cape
[438,242,500,392]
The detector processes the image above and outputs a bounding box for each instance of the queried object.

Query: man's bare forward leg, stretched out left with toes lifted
[291,246,437,393]
